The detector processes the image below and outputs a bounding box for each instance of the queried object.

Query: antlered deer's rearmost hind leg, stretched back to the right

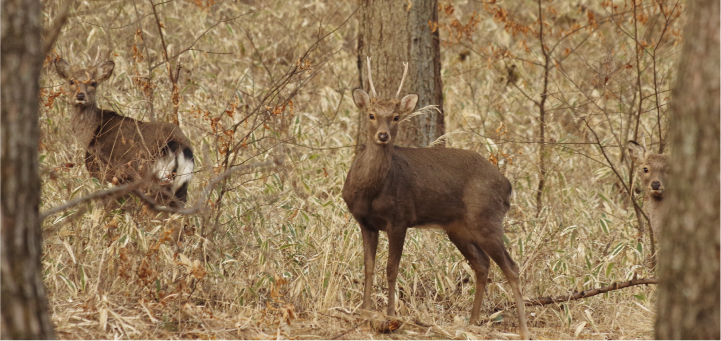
[476,222,531,339]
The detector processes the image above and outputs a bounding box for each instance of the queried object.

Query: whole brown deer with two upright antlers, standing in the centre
[343,59,530,338]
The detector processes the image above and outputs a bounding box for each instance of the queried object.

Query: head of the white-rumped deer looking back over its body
[55,59,115,107]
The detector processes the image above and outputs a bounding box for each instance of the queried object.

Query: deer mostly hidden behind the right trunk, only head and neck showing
[627,141,668,232]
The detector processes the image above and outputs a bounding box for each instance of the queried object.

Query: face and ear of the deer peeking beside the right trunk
[628,141,668,200]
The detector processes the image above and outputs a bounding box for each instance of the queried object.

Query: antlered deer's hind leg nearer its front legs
[448,227,491,324]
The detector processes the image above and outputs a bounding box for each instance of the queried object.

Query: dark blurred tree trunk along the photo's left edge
[0,0,55,339]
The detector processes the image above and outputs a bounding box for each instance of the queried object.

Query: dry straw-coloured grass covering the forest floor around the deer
[40,0,676,339]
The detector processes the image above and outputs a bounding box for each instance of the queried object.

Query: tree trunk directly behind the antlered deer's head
[357,0,445,147]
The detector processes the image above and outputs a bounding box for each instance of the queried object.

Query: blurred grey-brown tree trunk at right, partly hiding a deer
[656,0,721,340]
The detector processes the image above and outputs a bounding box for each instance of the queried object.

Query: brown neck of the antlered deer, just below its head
[352,141,393,194]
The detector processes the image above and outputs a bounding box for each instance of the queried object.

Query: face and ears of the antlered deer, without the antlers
[353,89,418,145]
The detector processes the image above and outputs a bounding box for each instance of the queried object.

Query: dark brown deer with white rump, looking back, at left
[55,58,195,207]
